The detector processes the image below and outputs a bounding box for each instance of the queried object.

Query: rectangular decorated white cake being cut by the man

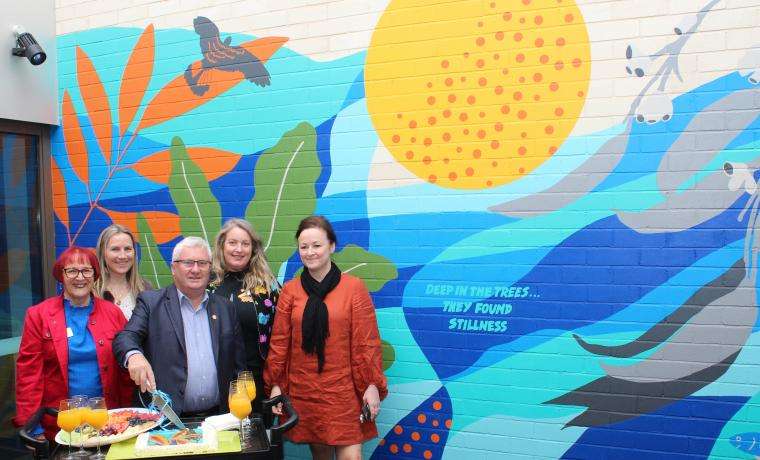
[135,423,218,457]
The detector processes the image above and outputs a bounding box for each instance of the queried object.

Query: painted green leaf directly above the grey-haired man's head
[169,137,222,242]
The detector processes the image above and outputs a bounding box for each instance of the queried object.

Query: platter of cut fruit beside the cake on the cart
[55,407,161,447]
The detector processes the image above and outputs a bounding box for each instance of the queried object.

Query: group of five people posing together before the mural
[14,216,388,459]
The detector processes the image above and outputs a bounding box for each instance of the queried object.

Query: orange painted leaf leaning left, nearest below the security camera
[77,46,113,165]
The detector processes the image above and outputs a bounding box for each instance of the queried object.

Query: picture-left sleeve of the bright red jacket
[13,309,45,426]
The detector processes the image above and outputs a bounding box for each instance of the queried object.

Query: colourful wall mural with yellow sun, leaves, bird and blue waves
[52,0,760,459]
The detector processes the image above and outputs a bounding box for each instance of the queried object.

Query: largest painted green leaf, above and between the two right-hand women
[245,122,322,275]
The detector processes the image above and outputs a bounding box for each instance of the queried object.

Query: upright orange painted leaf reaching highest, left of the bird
[119,24,155,136]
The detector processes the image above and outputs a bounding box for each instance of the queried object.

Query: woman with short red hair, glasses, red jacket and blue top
[13,246,134,439]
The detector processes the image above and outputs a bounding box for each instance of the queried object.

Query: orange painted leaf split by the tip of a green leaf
[132,147,240,184]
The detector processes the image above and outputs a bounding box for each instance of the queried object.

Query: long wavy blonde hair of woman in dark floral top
[211,218,277,292]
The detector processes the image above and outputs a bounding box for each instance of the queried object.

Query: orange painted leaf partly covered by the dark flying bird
[137,37,288,131]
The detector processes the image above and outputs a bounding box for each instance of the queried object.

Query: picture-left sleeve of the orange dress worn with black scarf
[264,284,293,396]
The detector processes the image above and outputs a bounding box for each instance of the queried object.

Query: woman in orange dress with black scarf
[264,216,388,460]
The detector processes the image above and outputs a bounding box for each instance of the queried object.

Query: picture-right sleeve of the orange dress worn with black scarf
[351,279,388,400]
